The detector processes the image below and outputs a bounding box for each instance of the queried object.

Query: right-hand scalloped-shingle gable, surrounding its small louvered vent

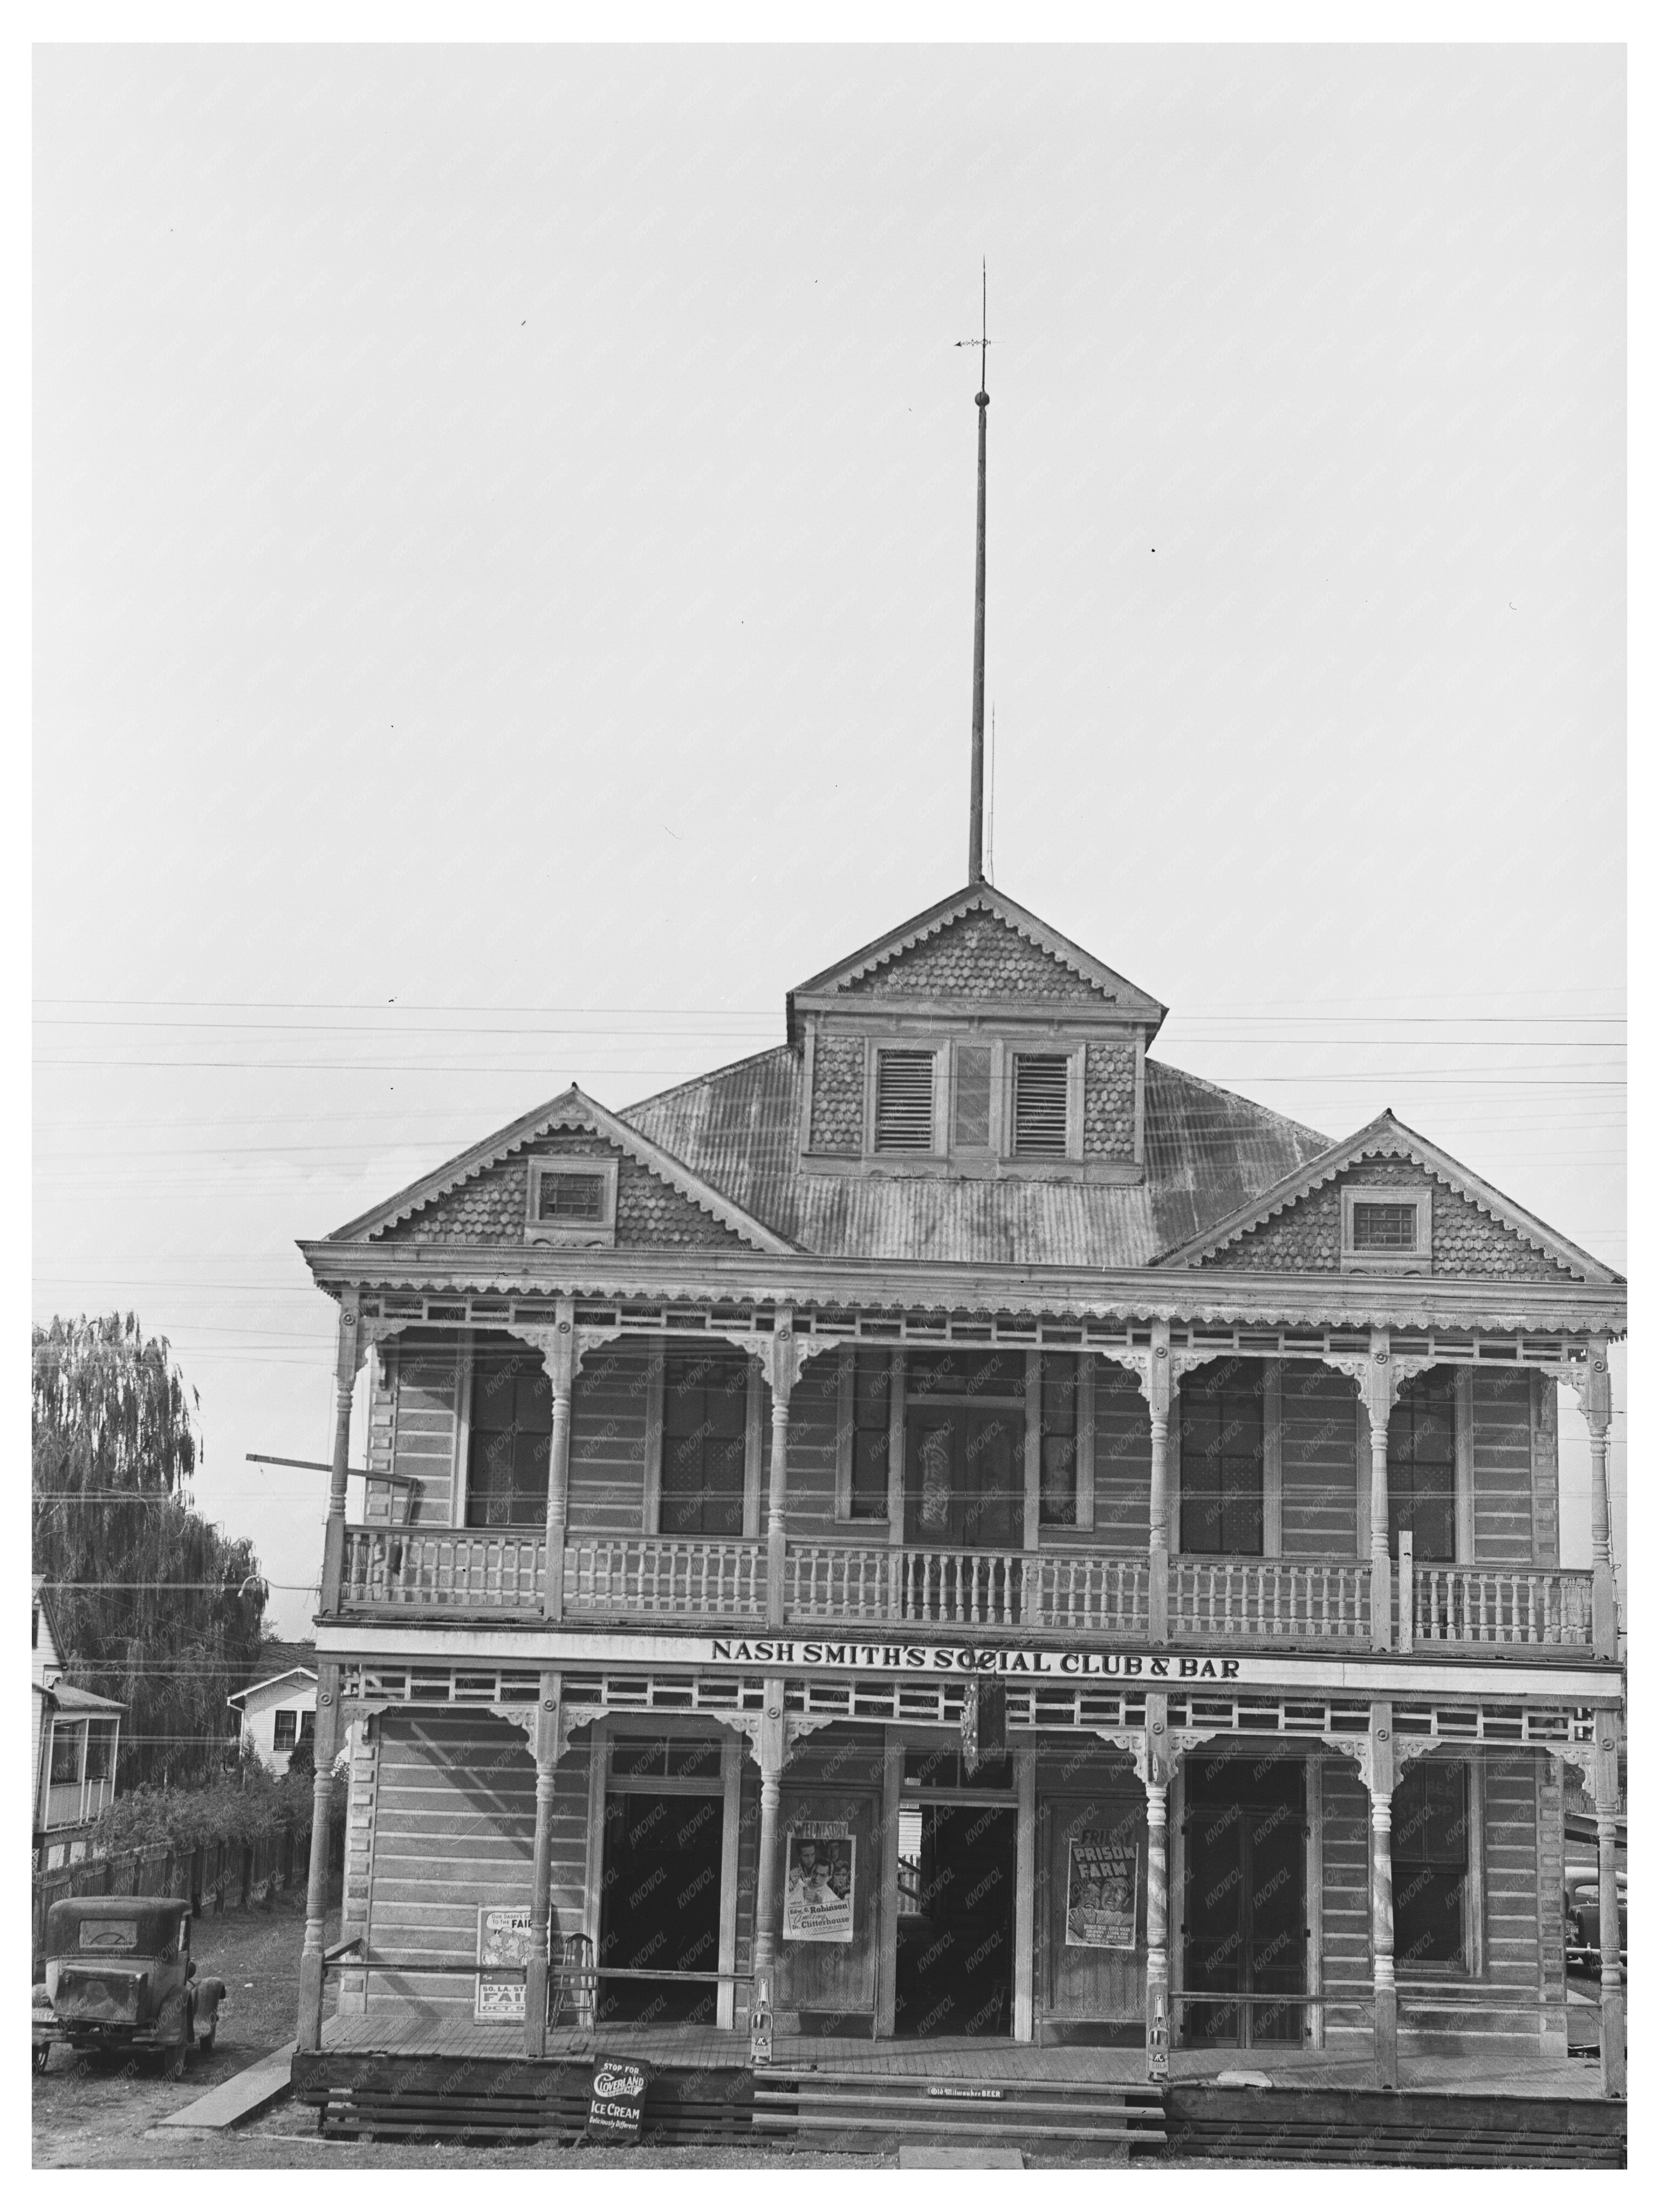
[1164,1115,1617,1283]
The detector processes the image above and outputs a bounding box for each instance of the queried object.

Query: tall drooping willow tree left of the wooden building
[33,1314,266,1787]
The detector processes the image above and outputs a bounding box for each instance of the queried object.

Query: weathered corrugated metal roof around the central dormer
[624,1044,1327,1268]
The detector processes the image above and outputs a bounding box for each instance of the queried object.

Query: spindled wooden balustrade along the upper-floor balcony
[341,1524,1593,1657]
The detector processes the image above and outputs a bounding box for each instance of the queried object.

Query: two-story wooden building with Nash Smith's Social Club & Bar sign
[285,881,1626,2123]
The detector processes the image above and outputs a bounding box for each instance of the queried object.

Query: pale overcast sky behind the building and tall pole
[33,46,1626,1632]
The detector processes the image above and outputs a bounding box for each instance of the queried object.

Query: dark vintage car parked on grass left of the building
[31,1898,226,2079]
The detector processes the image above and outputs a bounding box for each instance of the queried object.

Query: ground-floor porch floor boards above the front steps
[323,2002,1602,2099]
